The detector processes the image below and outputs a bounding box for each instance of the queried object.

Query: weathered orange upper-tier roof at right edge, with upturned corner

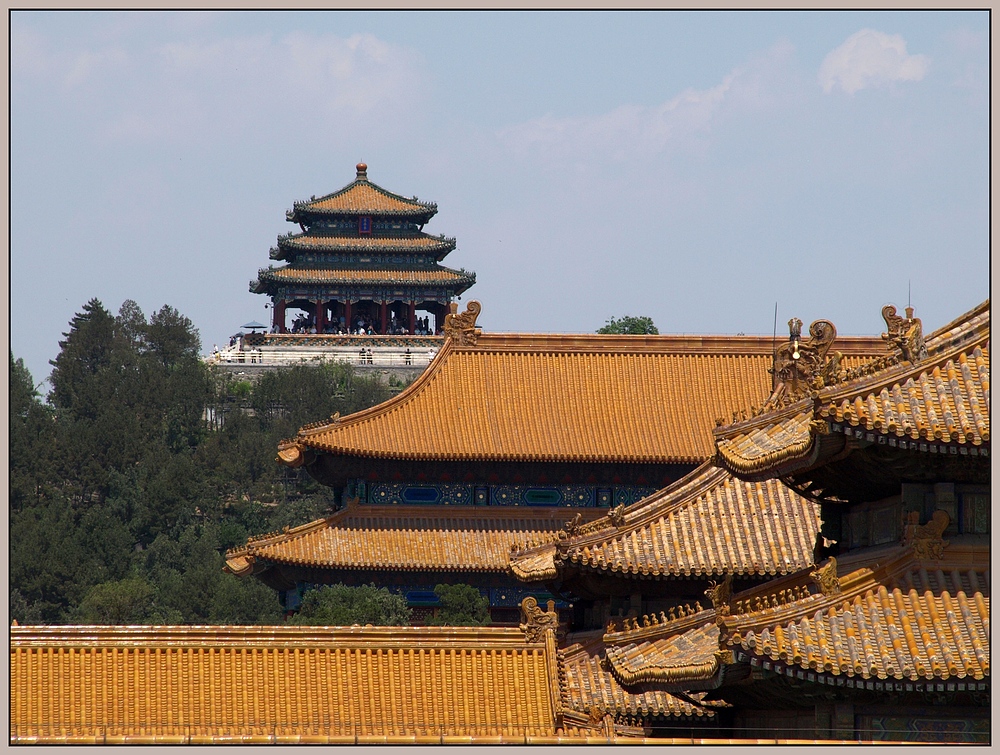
[715,302,990,476]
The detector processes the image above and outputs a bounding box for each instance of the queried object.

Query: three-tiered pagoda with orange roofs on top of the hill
[250,163,476,335]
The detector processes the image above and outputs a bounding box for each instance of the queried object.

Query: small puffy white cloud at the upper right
[819,29,930,94]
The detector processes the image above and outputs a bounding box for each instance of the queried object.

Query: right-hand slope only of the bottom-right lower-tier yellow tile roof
[728,543,990,681]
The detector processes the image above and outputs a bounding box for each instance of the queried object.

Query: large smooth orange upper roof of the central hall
[282,334,884,463]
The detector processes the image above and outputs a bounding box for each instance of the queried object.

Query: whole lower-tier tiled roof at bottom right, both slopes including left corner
[604,543,989,689]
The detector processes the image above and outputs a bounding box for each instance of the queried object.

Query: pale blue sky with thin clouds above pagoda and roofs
[10,11,990,394]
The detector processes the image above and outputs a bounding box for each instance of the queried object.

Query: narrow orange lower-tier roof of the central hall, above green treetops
[226,504,601,575]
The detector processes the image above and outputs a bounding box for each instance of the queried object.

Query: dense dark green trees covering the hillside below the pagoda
[9,299,389,624]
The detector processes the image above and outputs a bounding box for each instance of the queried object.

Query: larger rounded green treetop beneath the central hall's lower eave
[288,584,412,627]
